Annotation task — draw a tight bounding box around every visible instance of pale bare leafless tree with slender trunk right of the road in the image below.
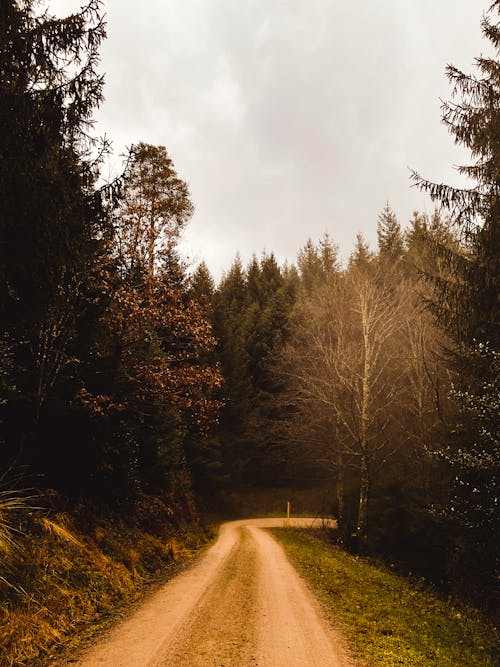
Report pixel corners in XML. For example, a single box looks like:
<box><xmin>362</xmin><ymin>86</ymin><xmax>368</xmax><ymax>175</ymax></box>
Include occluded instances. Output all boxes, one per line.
<box><xmin>282</xmin><ymin>267</ymin><xmax>406</xmax><ymax>538</ymax></box>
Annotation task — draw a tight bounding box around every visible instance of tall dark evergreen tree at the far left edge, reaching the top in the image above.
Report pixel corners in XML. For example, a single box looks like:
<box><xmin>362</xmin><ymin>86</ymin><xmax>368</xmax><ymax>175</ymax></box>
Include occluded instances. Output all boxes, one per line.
<box><xmin>0</xmin><ymin>0</ymin><xmax>106</xmax><ymax>483</ymax></box>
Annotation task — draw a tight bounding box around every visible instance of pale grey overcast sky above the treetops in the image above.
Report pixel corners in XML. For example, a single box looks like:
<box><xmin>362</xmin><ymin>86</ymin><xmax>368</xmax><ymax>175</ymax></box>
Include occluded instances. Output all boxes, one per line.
<box><xmin>50</xmin><ymin>0</ymin><xmax>487</xmax><ymax>277</ymax></box>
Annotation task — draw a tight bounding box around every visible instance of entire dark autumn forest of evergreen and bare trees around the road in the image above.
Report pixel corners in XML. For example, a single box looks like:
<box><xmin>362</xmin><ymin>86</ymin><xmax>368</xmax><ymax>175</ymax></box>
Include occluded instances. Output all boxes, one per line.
<box><xmin>0</xmin><ymin>0</ymin><xmax>500</xmax><ymax>652</ymax></box>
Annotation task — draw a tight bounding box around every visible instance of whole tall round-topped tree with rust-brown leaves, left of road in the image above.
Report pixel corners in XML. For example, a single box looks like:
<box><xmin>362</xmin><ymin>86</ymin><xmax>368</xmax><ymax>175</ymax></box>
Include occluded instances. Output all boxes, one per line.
<box><xmin>89</xmin><ymin>143</ymin><xmax>221</xmax><ymax>492</ymax></box>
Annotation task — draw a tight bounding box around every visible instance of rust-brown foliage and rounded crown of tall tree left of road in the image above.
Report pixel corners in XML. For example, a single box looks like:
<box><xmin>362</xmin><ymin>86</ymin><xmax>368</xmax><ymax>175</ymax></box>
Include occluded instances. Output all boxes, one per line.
<box><xmin>87</xmin><ymin>144</ymin><xmax>222</xmax><ymax>432</ymax></box>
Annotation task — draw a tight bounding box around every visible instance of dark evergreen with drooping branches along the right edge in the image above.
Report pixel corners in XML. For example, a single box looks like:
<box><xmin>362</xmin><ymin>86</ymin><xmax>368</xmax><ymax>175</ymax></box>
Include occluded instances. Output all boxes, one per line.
<box><xmin>413</xmin><ymin>0</ymin><xmax>500</xmax><ymax>601</ymax></box>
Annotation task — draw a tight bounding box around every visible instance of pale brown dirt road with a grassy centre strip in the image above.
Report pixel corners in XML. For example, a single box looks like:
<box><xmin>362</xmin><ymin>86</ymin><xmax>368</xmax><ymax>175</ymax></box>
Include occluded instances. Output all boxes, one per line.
<box><xmin>77</xmin><ymin>519</ymin><xmax>352</xmax><ymax>667</ymax></box>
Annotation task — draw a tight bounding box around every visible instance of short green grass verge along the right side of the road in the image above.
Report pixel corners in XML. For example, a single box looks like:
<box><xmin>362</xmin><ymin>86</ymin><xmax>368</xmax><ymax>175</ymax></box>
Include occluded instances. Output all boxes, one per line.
<box><xmin>271</xmin><ymin>528</ymin><xmax>500</xmax><ymax>667</ymax></box>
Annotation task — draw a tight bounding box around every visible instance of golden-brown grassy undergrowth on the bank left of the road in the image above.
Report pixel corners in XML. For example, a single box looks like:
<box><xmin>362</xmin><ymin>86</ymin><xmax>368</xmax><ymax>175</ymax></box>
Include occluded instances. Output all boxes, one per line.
<box><xmin>0</xmin><ymin>497</ymin><xmax>208</xmax><ymax>667</ymax></box>
